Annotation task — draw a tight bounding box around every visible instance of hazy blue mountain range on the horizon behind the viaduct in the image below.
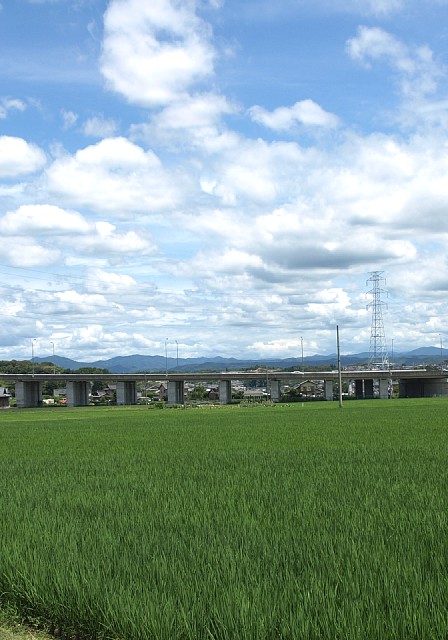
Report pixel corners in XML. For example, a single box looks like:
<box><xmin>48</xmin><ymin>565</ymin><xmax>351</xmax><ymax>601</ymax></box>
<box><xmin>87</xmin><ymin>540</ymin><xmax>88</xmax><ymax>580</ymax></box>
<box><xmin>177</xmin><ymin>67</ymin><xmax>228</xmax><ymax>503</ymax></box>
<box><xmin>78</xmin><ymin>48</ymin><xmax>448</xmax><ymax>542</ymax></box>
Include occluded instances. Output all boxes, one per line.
<box><xmin>33</xmin><ymin>347</ymin><xmax>448</xmax><ymax>373</ymax></box>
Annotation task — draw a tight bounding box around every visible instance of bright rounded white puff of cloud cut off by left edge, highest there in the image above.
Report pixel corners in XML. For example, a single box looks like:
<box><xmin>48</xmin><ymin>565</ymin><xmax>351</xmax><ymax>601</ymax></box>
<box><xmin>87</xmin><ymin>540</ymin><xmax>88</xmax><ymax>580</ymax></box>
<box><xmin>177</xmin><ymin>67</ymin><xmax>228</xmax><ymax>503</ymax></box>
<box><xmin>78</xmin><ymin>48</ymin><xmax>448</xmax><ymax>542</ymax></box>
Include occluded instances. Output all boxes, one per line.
<box><xmin>0</xmin><ymin>136</ymin><xmax>47</xmax><ymax>178</ymax></box>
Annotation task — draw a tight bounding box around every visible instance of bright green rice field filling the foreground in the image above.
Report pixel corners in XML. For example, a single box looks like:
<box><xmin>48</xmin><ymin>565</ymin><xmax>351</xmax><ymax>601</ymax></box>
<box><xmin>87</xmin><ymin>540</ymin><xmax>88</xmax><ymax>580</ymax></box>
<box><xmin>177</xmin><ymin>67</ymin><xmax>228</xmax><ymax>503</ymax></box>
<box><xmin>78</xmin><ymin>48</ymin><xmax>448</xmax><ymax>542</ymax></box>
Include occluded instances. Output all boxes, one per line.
<box><xmin>0</xmin><ymin>398</ymin><xmax>448</xmax><ymax>640</ymax></box>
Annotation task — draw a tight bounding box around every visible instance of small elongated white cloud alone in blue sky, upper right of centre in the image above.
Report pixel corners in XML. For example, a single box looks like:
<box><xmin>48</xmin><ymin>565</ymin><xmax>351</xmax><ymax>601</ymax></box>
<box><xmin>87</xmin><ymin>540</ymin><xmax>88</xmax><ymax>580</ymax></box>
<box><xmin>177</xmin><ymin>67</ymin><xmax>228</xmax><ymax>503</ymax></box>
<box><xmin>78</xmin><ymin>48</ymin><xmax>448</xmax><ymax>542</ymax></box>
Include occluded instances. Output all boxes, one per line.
<box><xmin>249</xmin><ymin>100</ymin><xmax>339</xmax><ymax>131</ymax></box>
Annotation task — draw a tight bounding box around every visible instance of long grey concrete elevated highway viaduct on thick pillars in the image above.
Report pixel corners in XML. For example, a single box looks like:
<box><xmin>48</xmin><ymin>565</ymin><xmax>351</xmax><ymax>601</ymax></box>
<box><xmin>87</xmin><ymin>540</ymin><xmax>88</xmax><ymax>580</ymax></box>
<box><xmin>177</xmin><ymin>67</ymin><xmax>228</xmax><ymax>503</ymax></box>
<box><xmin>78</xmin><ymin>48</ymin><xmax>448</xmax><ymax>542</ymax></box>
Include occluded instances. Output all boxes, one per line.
<box><xmin>0</xmin><ymin>369</ymin><xmax>448</xmax><ymax>408</ymax></box>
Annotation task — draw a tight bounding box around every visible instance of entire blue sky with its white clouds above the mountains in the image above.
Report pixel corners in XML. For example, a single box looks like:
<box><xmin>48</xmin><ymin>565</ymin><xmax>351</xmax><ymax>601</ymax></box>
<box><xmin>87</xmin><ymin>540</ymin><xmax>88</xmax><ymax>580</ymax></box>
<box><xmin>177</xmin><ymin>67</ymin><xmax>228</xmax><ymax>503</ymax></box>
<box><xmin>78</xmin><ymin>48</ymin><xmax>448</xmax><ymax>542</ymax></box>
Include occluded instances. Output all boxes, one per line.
<box><xmin>0</xmin><ymin>0</ymin><xmax>448</xmax><ymax>361</ymax></box>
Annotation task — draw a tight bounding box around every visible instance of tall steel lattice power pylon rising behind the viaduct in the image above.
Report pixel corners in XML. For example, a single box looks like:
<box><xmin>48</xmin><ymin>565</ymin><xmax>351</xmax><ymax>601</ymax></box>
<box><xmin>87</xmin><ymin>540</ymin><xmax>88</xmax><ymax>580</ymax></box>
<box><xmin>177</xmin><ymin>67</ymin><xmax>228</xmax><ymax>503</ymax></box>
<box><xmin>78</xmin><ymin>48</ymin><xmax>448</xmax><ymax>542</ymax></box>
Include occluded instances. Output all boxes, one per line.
<box><xmin>367</xmin><ymin>271</ymin><xmax>389</xmax><ymax>369</ymax></box>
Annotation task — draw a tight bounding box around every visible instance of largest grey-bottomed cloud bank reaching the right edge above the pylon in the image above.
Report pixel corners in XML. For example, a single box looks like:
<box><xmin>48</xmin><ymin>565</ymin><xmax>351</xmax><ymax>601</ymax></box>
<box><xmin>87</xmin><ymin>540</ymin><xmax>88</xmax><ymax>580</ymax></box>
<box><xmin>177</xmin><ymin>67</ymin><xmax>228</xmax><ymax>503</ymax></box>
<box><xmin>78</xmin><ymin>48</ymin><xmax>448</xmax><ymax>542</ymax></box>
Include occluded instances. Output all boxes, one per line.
<box><xmin>172</xmin><ymin>126</ymin><xmax>448</xmax><ymax>290</ymax></box>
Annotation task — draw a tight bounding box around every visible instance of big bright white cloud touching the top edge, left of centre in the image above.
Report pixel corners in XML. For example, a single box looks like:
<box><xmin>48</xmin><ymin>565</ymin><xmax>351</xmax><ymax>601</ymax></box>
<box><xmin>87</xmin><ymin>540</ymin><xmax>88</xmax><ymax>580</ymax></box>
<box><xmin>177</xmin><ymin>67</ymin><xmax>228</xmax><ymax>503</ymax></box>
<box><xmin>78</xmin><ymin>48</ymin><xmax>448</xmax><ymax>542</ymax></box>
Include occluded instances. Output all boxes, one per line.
<box><xmin>101</xmin><ymin>0</ymin><xmax>215</xmax><ymax>107</ymax></box>
